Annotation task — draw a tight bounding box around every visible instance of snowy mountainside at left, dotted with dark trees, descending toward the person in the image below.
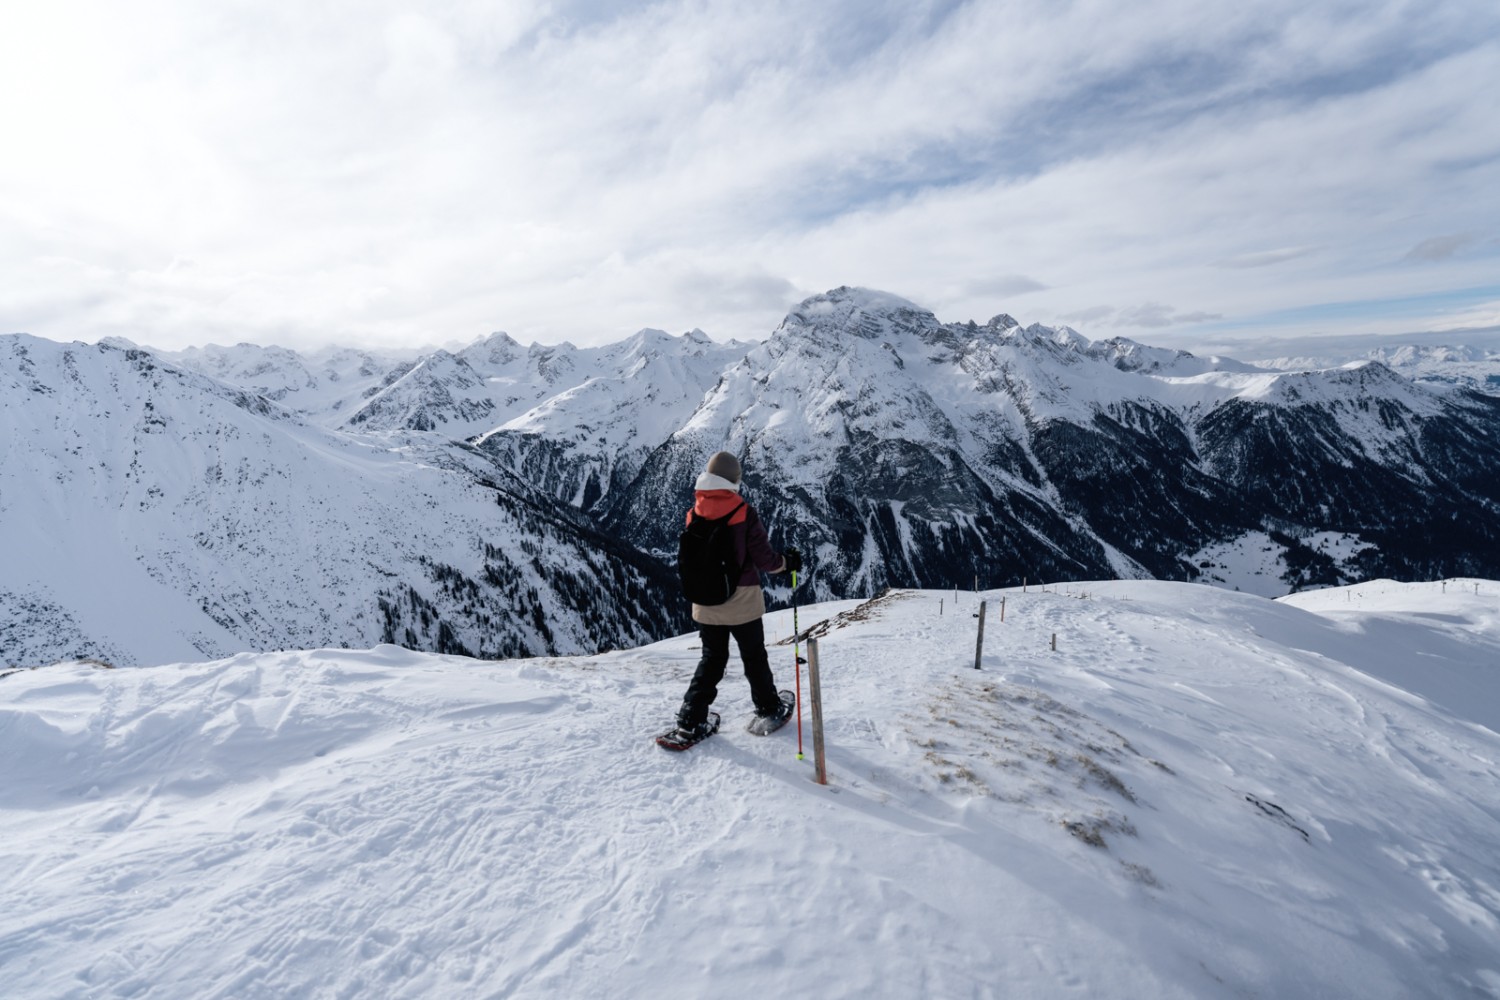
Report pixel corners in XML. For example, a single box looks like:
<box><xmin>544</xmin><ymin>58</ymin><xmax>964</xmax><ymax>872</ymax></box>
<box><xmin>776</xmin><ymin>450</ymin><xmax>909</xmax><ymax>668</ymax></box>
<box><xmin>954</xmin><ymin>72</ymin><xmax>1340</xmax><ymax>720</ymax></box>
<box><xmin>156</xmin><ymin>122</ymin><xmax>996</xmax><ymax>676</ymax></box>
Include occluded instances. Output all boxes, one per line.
<box><xmin>0</xmin><ymin>334</ymin><xmax>669</xmax><ymax>666</ymax></box>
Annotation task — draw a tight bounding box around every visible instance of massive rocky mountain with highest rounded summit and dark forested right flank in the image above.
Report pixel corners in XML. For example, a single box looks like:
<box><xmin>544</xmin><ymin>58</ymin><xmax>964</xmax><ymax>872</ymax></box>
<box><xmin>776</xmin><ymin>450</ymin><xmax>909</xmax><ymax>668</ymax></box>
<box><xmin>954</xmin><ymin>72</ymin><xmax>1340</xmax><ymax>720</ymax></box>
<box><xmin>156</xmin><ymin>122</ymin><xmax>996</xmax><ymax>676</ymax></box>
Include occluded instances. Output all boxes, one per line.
<box><xmin>599</xmin><ymin>289</ymin><xmax>1500</xmax><ymax>597</ymax></box>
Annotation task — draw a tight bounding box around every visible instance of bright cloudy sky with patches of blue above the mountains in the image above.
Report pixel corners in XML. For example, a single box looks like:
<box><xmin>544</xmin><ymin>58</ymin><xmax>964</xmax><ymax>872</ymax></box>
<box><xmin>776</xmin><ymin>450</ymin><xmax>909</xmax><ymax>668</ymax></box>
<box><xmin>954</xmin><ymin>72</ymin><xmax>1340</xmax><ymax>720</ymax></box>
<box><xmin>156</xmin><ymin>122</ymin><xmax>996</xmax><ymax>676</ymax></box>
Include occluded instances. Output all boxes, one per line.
<box><xmin>0</xmin><ymin>0</ymin><xmax>1500</xmax><ymax>348</ymax></box>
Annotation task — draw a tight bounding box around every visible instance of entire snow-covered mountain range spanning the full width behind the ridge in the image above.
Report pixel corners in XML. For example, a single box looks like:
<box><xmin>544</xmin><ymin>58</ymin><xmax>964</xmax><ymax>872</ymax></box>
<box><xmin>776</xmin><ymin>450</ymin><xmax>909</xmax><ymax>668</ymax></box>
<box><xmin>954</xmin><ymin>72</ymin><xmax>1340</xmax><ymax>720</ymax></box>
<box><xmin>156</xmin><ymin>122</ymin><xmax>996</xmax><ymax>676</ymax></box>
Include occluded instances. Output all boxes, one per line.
<box><xmin>0</xmin><ymin>288</ymin><xmax>1500</xmax><ymax>663</ymax></box>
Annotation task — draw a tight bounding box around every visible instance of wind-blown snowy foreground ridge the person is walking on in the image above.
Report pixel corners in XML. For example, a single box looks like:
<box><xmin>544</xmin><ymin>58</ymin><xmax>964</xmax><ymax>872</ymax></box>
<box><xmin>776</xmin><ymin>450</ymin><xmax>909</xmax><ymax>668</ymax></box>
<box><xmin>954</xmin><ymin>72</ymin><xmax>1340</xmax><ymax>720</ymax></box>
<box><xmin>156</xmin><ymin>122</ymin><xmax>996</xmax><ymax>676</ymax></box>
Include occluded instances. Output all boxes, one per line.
<box><xmin>0</xmin><ymin>580</ymin><xmax>1500</xmax><ymax>999</ymax></box>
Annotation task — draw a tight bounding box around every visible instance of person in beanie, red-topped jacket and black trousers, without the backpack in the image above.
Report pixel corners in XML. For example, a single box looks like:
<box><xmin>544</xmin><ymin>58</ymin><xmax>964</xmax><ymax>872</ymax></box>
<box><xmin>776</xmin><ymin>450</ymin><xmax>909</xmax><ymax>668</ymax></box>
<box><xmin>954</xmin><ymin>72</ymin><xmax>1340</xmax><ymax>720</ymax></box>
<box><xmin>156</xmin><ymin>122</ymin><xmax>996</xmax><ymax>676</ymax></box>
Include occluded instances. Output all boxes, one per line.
<box><xmin>677</xmin><ymin>451</ymin><xmax>803</xmax><ymax>735</ymax></box>
